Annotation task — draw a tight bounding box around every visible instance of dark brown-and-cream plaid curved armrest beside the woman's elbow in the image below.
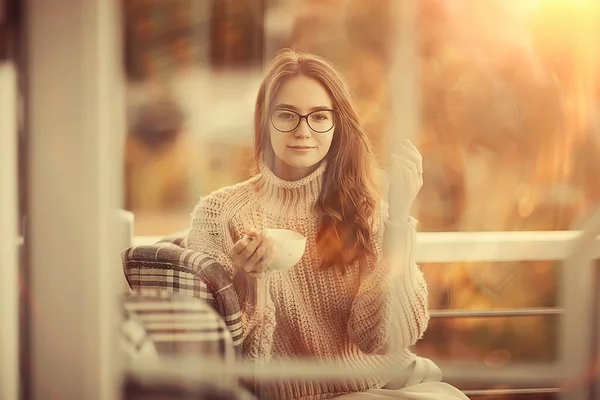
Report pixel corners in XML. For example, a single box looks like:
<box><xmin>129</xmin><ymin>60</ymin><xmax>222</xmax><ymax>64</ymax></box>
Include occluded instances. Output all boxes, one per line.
<box><xmin>122</xmin><ymin>237</ymin><xmax>242</xmax><ymax>351</ymax></box>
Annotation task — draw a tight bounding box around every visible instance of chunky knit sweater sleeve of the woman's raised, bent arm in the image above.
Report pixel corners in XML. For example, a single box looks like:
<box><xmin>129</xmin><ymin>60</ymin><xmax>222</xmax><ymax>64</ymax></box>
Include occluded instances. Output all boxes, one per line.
<box><xmin>348</xmin><ymin>205</ymin><xmax>429</xmax><ymax>354</ymax></box>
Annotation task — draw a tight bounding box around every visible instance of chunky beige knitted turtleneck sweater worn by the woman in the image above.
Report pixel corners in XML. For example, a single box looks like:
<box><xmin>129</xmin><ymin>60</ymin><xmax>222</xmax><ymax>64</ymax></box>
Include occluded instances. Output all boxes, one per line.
<box><xmin>186</xmin><ymin>164</ymin><xmax>429</xmax><ymax>399</ymax></box>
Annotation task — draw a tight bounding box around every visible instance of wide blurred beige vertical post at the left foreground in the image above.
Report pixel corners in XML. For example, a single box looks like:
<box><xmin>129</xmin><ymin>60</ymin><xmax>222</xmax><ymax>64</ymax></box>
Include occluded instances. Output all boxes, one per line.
<box><xmin>25</xmin><ymin>0</ymin><xmax>124</xmax><ymax>399</ymax></box>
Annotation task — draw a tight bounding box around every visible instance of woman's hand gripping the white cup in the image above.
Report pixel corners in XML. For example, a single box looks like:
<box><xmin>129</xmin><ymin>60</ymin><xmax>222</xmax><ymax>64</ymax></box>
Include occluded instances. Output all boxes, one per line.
<box><xmin>229</xmin><ymin>229</ymin><xmax>275</xmax><ymax>276</ymax></box>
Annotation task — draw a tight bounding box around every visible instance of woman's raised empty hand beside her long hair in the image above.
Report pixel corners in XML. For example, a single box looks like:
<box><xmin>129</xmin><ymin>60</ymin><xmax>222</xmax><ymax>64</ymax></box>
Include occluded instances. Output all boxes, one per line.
<box><xmin>388</xmin><ymin>139</ymin><xmax>423</xmax><ymax>223</ymax></box>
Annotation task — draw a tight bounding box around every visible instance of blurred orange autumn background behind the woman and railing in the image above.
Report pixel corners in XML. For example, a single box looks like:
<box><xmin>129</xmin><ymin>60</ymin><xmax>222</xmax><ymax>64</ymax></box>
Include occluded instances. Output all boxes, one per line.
<box><xmin>3</xmin><ymin>0</ymin><xmax>600</xmax><ymax>399</ymax></box>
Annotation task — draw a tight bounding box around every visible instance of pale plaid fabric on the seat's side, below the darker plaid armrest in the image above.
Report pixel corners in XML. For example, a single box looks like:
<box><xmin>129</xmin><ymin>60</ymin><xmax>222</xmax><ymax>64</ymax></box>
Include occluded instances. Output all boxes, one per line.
<box><xmin>121</xmin><ymin>289</ymin><xmax>255</xmax><ymax>400</ymax></box>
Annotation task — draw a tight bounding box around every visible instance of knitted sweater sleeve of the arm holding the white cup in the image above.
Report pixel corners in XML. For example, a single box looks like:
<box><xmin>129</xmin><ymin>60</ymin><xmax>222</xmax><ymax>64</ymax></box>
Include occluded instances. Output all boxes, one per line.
<box><xmin>186</xmin><ymin>190</ymin><xmax>275</xmax><ymax>360</ymax></box>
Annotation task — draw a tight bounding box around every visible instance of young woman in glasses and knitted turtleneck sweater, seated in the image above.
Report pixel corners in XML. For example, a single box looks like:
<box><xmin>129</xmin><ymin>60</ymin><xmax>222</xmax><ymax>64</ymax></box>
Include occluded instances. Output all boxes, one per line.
<box><xmin>187</xmin><ymin>50</ymin><xmax>466</xmax><ymax>399</ymax></box>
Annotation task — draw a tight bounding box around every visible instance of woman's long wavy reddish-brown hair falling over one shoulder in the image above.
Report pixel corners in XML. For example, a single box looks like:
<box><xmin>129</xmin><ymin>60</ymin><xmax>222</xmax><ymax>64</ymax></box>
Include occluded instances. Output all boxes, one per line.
<box><xmin>254</xmin><ymin>49</ymin><xmax>379</xmax><ymax>270</ymax></box>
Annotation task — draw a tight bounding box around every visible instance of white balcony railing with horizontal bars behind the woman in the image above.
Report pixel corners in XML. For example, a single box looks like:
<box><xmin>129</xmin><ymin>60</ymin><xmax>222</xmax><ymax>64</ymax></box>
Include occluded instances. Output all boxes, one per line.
<box><xmin>133</xmin><ymin>231</ymin><xmax>600</xmax><ymax>399</ymax></box>
